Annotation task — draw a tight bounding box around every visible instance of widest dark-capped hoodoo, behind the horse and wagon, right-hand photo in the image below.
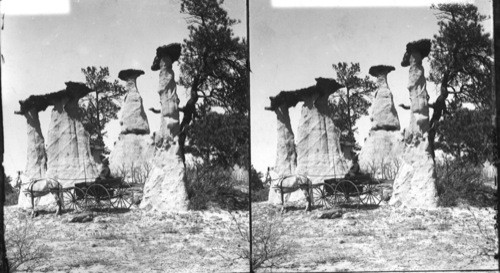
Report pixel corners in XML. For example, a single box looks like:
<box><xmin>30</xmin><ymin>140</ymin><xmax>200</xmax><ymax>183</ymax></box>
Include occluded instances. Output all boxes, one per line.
<box><xmin>296</xmin><ymin>78</ymin><xmax>347</xmax><ymax>184</ymax></box>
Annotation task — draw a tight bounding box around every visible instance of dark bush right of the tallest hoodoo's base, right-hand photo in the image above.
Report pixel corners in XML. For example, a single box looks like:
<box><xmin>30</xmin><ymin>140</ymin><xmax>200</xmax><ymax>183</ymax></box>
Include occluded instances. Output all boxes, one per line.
<box><xmin>436</xmin><ymin>159</ymin><xmax>496</xmax><ymax>207</ymax></box>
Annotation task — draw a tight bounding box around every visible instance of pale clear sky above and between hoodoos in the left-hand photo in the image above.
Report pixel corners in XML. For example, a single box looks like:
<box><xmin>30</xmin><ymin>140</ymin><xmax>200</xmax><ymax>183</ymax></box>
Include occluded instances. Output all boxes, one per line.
<box><xmin>1</xmin><ymin>0</ymin><xmax>247</xmax><ymax>178</ymax></box>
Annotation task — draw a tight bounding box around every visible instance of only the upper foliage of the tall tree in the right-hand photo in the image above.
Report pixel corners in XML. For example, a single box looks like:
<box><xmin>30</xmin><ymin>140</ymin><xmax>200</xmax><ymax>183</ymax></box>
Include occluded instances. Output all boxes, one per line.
<box><xmin>429</xmin><ymin>4</ymin><xmax>493</xmax><ymax>109</ymax></box>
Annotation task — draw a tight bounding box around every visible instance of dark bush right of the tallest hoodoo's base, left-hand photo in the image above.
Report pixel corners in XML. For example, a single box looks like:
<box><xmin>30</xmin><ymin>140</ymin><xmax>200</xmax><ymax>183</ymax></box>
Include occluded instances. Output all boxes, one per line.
<box><xmin>186</xmin><ymin>163</ymin><xmax>249</xmax><ymax>210</ymax></box>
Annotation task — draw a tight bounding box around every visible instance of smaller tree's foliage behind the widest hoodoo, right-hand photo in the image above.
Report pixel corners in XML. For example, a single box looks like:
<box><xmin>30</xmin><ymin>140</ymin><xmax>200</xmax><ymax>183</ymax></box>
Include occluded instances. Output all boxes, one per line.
<box><xmin>330</xmin><ymin>62</ymin><xmax>376</xmax><ymax>146</ymax></box>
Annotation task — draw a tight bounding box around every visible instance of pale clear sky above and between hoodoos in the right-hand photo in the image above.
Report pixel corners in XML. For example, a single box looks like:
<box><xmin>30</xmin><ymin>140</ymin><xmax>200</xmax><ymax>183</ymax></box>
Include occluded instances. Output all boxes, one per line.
<box><xmin>249</xmin><ymin>0</ymin><xmax>492</xmax><ymax>173</ymax></box>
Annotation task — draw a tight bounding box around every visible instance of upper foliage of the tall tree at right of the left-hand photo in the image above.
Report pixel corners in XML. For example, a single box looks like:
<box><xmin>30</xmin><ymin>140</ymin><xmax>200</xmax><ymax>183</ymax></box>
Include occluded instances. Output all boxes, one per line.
<box><xmin>180</xmin><ymin>0</ymin><xmax>249</xmax><ymax>113</ymax></box>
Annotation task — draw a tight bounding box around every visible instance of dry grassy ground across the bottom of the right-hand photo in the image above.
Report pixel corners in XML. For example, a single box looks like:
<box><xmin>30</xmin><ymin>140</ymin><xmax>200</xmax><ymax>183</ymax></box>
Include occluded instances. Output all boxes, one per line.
<box><xmin>252</xmin><ymin>199</ymin><xmax>498</xmax><ymax>272</ymax></box>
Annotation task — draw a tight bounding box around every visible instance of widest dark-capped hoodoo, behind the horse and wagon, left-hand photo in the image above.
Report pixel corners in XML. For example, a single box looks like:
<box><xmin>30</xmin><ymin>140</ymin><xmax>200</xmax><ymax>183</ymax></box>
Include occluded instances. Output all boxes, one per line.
<box><xmin>44</xmin><ymin>82</ymin><xmax>97</xmax><ymax>187</ymax></box>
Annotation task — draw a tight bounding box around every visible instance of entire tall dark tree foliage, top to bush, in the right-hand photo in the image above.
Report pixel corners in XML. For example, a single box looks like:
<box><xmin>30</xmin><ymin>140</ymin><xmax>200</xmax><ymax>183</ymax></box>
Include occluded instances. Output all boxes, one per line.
<box><xmin>429</xmin><ymin>4</ymin><xmax>495</xmax><ymax>163</ymax></box>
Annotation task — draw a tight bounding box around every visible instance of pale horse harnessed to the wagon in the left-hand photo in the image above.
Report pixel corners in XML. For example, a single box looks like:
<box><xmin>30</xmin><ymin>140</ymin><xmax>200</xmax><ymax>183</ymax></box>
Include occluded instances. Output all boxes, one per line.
<box><xmin>24</xmin><ymin>178</ymin><xmax>64</xmax><ymax>218</ymax></box>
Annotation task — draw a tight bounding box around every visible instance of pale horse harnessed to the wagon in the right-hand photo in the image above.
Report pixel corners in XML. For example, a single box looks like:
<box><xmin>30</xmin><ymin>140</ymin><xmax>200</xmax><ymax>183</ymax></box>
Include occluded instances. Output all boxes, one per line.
<box><xmin>272</xmin><ymin>174</ymin><xmax>313</xmax><ymax>213</ymax></box>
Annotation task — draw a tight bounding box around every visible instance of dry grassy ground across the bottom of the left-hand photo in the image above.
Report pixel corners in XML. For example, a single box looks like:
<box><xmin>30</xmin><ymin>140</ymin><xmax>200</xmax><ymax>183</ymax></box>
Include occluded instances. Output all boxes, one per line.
<box><xmin>5</xmin><ymin>207</ymin><xmax>249</xmax><ymax>272</ymax></box>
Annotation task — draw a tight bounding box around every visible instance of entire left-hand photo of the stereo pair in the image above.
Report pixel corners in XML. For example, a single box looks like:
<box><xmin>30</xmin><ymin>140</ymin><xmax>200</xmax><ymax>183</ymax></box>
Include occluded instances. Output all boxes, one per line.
<box><xmin>0</xmin><ymin>0</ymin><xmax>252</xmax><ymax>272</ymax></box>
